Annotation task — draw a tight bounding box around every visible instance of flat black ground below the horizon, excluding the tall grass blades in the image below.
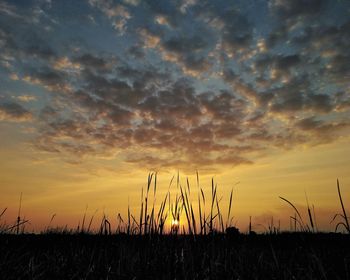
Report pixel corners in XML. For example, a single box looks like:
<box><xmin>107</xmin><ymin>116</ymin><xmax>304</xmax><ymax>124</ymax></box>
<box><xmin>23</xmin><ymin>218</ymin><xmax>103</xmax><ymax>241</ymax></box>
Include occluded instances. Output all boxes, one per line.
<box><xmin>0</xmin><ymin>234</ymin><xmax>350</xmax><ymax>280</ymax></box>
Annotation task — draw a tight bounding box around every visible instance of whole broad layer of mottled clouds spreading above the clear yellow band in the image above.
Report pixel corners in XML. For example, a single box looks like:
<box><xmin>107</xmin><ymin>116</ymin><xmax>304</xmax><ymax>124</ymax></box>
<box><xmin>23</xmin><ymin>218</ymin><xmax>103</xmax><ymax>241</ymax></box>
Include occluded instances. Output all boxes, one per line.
<box><xmin>0</xmin><ymin>0</ymin><xmax>350</xmax><ymax>171</ymax></box>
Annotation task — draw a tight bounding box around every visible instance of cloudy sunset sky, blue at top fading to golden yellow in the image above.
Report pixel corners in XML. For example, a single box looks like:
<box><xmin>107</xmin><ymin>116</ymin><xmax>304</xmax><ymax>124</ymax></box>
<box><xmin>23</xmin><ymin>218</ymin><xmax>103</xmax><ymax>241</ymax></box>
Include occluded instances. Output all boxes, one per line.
<box><xmin>0</xmin><ymin>0</ymin><xmax>350</xmax><ymax>230</ymax></box>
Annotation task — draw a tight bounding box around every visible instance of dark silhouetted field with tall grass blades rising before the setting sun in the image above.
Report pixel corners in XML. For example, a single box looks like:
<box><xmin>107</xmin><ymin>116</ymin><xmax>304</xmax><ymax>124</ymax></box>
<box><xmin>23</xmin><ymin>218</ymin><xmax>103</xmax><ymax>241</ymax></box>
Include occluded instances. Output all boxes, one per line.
<box><xmin>0</xmin><ymin>174</ymin><xmax>350</xmax><ymax>279</ymax></box>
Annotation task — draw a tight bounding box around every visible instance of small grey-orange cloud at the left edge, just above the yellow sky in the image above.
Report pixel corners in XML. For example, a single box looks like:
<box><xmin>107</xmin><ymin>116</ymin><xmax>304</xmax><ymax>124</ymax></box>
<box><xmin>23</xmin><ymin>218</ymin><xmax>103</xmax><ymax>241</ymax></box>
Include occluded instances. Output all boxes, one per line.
<box><xmin>0</xmin><ymin>102</ymin><xmax>33</xmax><ymax>122</ymax></box>
